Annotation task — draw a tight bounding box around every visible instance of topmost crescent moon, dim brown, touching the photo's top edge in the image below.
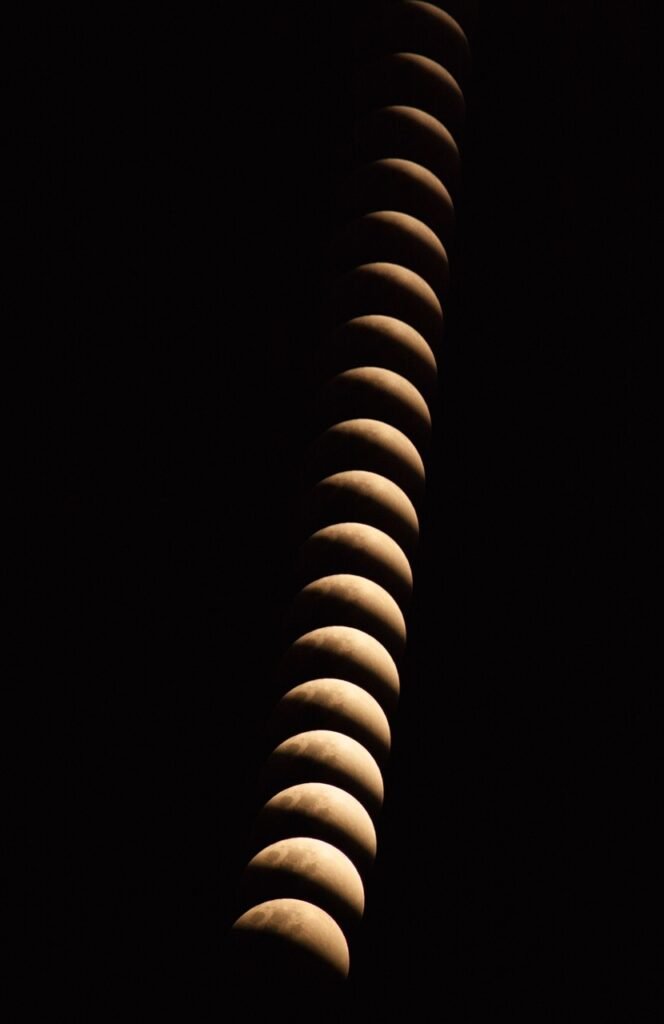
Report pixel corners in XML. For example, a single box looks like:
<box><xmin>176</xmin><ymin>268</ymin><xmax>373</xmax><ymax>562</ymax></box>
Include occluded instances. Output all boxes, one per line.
<box><xmin>365</xmin><ymin>0</ymin><xmax>470</xmax><ymax>83</ymax></box>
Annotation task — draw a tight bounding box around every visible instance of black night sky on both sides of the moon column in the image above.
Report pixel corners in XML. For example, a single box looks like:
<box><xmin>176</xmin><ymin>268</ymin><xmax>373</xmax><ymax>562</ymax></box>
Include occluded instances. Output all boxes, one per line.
<box><xmin>29</xmin><ymin>0</ymin><xmax>647</xmax><ymax>1022</ymax></box>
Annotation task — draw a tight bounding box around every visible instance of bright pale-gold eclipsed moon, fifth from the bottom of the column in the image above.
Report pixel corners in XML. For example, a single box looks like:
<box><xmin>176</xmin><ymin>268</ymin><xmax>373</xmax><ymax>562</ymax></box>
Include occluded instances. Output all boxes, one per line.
<box><xmin>268</xmin><ymin>679</ymin><xmax>391</xmax><ymax>764</ymax></box>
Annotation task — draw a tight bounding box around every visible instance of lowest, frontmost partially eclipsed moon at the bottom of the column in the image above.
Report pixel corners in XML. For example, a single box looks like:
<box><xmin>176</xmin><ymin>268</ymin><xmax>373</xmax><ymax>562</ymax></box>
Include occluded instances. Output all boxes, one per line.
<box><xmin>232</xmin><ymin>898</ymin><xmax>349</xmax><ymax>994</ymax></box>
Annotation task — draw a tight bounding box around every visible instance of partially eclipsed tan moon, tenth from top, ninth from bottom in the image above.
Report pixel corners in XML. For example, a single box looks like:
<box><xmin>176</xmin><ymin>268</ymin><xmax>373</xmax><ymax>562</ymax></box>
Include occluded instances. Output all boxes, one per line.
<box><xmin>304</xmin><ymin>469</ymin><xmax>419</xmax><ymax>556</ymax></box>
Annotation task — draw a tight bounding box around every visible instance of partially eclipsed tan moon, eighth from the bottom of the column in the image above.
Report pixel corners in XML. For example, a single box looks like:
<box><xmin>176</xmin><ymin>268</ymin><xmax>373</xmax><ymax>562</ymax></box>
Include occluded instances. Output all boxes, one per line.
<box><xmin>297</xmin><ymin>522</ymin><xmax>413</xmax><ymax>612</ymax></box>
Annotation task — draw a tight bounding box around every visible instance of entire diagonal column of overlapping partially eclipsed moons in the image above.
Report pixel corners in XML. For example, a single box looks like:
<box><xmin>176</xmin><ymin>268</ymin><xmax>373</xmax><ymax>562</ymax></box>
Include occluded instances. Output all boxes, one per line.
<box><xmin>232</xmin><ymin>0</ymin><xmax>476</xmax><ymax>986</ymax></box>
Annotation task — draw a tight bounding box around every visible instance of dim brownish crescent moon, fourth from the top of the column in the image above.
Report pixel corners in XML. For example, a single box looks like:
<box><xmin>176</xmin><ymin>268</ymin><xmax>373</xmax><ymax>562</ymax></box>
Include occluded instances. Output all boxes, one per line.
<box><xmin>339</xmin><ymin>157</ymin><xmax>454</xmax><ymax>245</ymax></box>
